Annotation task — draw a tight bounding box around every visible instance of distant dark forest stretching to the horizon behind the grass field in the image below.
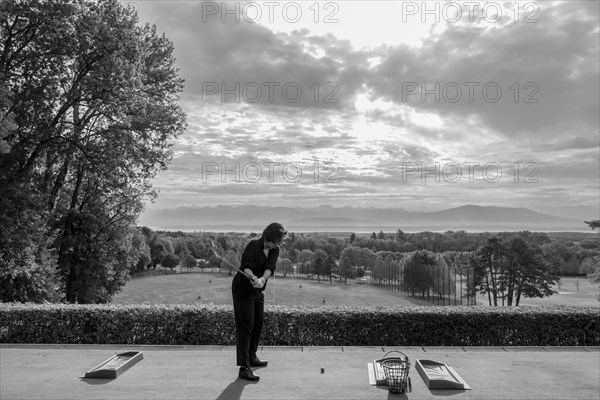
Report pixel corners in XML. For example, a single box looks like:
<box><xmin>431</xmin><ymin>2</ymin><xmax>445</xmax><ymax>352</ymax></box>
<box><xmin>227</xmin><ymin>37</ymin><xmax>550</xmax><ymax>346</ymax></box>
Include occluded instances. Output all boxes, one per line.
<box><xmin>143</xmin><ymin>227</ymin><xmax>600</xmax><ymax>276</ymax></box>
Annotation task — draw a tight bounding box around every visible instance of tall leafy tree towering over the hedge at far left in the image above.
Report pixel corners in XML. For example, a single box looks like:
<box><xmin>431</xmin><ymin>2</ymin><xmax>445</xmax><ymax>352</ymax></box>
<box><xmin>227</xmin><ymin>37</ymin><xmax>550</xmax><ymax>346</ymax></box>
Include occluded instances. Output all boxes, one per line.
<box><xmin>0</xmin><ymin>0</ymin><xmax>185</xmax><ymax>303</ymax></box>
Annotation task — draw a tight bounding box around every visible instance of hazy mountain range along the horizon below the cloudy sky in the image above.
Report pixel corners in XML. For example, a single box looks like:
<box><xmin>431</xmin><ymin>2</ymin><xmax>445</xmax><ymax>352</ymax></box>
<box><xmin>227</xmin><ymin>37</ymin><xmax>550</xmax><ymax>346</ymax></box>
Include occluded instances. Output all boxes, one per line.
<box><xmin>139</xmin><ymin>205</ymin><xmax>593</xmax><ymax>232</ymax></box>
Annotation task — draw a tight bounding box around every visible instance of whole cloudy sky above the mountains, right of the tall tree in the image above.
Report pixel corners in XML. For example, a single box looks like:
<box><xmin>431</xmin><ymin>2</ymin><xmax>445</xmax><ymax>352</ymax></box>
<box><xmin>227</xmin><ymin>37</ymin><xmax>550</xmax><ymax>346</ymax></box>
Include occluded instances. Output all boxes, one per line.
<box><xmin>132</xmin><ymin>0</ymin><xmax>600</xmax><ymax>218</ymax></box>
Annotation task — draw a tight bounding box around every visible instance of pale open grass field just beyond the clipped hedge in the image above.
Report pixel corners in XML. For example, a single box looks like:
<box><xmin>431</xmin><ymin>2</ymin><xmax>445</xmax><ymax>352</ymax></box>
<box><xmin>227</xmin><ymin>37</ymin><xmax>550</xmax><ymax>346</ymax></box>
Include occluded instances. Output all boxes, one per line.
<box><xmin>113</xmin><ymin>272</ymin><xmax>600</xmax><ymax>307</ymax></box>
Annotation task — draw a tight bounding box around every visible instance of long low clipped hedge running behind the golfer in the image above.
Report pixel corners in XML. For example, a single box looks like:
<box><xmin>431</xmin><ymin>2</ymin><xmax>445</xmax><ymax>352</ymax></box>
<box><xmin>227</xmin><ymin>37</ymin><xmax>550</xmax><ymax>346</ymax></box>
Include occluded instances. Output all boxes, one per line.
<box><xmin>0</xmin><ymin>304</ymin><xmax>600</xmax><ymax>346</ymax></box>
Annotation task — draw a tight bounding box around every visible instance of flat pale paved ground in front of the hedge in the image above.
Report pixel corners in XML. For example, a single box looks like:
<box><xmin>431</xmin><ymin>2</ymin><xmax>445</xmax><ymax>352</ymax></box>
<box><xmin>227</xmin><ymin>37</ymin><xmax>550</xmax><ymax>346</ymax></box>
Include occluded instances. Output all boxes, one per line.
<box><xmin>0</xmin><ymin>344</ymin><xmax>600</xmax><ymax>400</ymax></box>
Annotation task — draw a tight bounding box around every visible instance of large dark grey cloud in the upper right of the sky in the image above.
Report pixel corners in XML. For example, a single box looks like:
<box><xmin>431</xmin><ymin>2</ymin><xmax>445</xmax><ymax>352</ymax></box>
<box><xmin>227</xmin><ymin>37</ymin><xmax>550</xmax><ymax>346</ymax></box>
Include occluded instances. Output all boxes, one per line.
<box><xmin>369</xmin><ymin>2</ymin><xmax>600</xmax><ymax>139</ymax></box>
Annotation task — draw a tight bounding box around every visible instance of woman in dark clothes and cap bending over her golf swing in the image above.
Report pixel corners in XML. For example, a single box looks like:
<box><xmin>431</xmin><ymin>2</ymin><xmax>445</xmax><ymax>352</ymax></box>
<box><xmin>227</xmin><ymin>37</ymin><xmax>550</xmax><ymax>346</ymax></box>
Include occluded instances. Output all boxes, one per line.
<box><xmin>231</xmin><ymin>222</ymin><xmax>287</xmax><ymax>381</ymax></box>
